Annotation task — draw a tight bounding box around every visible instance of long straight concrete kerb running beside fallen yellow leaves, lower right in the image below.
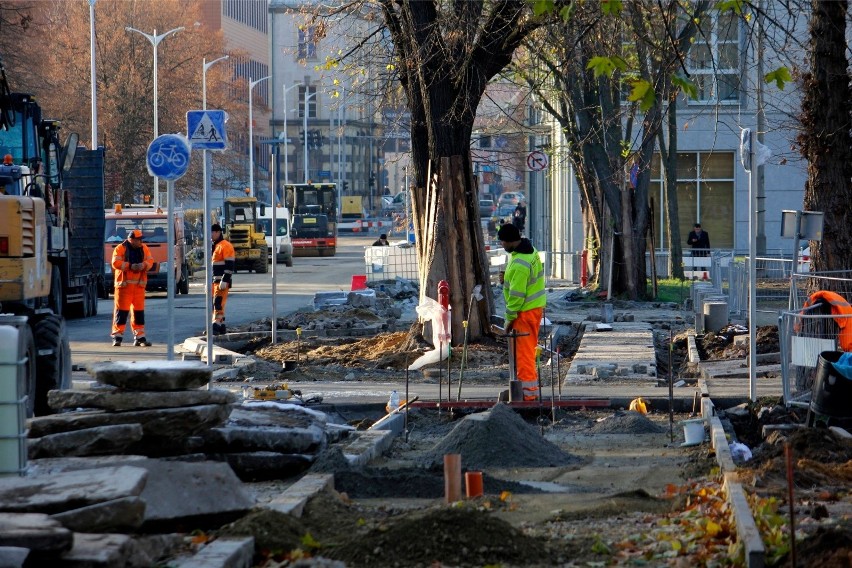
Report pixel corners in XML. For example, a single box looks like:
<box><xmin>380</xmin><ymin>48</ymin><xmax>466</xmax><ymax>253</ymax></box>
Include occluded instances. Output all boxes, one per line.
<box><xmin>701</xmin><ymin>397</ymin><xmax>766</xmax><ymax>568</ymax></box>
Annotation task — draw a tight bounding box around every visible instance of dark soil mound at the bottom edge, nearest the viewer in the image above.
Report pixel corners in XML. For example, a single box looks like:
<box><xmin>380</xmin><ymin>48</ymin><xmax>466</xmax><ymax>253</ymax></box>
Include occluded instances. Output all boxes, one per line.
<box><xmin>325</xmin><ymin>507</ymin><xmax>550</xmax><ymax>567</ymax></box>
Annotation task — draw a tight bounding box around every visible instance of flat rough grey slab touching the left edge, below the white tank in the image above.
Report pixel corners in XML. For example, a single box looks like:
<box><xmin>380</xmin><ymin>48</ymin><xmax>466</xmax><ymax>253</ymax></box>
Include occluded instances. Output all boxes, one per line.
<box><xmin>0</xmin><ymin>462</ymin><xmax>148</xmax><ymax>513</ymax></box>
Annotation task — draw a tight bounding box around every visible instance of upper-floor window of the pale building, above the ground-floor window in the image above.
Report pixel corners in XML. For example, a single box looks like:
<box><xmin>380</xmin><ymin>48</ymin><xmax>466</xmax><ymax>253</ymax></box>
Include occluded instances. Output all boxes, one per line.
<box><xmin>687</xmin><ymin>10</ymin><xmax>740</xmax><ymax>104</ymax></box>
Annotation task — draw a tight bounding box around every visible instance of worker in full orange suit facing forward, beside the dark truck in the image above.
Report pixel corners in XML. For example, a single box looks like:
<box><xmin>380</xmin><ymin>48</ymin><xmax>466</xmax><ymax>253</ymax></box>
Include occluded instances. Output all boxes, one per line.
<box><xmin>111</xmin><ymin>229</ymin><xmax>154</xmax><ymax>347</ymax></box>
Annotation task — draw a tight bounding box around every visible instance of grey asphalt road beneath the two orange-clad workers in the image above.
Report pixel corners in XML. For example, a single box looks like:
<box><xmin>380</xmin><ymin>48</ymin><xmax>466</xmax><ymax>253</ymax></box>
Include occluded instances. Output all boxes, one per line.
<box><xmin>66</xmin><ymin>235</ymin><xmax>376</xmax><ymax>366</ymax></box>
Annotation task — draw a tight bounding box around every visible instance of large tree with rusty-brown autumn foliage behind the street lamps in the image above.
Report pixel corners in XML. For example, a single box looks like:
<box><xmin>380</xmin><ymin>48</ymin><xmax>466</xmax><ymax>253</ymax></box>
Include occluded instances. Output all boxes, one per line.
<box><xmin>0</xmin><ymin>0</ymin><xmax>247</xmax><ymax>203</ymax></box>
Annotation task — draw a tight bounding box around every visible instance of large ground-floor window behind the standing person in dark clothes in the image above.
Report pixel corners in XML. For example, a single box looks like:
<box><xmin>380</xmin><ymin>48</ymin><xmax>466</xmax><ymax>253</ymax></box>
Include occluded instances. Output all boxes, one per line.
<box><xmin>651</xmin><ymin>152</ymin><xmax>735</xmax><ymax>248</ymax></box>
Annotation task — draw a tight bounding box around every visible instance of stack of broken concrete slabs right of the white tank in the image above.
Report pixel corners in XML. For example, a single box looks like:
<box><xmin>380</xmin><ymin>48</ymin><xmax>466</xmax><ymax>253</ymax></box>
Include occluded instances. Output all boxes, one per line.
<box><xmin>28</xmin><ymin>361</ymin><xmax>237</xmax><ymax>459</ymax></box>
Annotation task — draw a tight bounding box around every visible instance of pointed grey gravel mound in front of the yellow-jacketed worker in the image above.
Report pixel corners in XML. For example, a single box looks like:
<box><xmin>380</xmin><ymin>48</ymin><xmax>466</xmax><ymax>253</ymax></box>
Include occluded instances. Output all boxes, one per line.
<box><xmin>427</xmin><ymin>404</ymin><xmax>580</xmax><ymax>470</ymax></box>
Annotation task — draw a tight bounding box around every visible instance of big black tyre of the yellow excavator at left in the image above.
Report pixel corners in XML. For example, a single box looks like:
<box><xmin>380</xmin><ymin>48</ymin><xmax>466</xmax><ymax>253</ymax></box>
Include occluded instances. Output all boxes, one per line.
<box><xmin>33</xmin><ymin>315</ymin><xmax>71</xmax><ymax>416</ymax></box>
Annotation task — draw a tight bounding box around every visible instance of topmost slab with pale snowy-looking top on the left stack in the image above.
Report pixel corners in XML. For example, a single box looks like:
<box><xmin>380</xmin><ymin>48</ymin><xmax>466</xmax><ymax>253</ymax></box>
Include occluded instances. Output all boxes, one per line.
<box><xmin>88</xmin><ymin>361</ymin><xmax>213</xmax><ymax>391</ymax></box>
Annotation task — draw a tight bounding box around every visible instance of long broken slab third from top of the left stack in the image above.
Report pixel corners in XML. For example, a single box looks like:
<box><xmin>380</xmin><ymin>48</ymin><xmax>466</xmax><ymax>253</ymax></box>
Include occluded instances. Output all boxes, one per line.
<box><xmin>28</xmin><ymin>404</ymin><xmax>231</xmax><ymax>439</ymax></box>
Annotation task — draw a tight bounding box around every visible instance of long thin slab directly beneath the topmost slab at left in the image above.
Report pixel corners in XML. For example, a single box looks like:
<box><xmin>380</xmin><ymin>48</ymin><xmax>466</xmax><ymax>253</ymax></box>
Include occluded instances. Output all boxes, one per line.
<box><xmin>47</xmin><ymin>389</ymin><xmax>238</xmax><ymax>412</ymax></box>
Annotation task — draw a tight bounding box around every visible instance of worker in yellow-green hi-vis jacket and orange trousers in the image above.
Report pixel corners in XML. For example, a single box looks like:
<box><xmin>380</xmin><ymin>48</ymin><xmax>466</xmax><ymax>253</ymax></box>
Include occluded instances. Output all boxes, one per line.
<box><xmin>497</xmin><ymin>223</ymin><xmax>547</xmax><ymax>400</ymax></box>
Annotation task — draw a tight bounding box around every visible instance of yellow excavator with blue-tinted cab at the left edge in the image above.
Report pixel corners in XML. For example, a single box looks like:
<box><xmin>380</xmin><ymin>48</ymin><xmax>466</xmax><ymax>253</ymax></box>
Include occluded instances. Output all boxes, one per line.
<box><xmin>0</xmin><ymin>58</ymin><xmax>93</xmax><ymax>416</ymax></box>
